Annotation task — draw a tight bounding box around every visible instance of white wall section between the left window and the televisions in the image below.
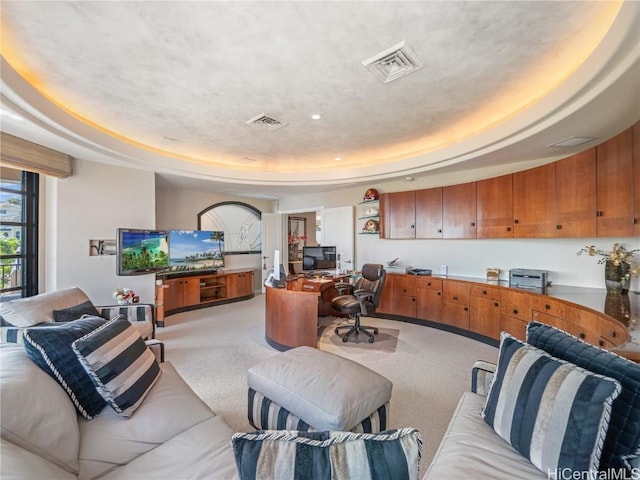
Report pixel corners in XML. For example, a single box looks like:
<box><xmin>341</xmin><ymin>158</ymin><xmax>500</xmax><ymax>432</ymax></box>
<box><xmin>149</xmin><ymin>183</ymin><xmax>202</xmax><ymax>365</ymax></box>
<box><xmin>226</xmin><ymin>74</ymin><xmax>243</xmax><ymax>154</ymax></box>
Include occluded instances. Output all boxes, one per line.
<box><xmin>43</xmin><ymin>160</ymin><xmax>156</xmax><ymax>305</ymax></box>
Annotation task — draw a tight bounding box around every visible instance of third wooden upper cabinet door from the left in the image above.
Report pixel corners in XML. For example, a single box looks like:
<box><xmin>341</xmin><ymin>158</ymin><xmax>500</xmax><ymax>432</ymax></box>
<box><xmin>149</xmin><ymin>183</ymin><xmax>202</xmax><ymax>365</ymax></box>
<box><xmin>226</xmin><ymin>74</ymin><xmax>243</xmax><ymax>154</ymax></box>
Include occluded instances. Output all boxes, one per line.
<box><xmin>442</xmin><ymin>182</ymin><xmax>476</xmax><ymax>238</ymax></box>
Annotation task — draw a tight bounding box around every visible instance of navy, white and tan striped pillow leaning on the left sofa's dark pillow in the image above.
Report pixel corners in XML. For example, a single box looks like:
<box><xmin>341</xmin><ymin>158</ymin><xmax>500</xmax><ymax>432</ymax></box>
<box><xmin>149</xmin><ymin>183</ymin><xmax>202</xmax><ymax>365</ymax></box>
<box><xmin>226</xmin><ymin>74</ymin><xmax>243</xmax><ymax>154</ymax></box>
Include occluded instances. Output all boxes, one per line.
<box><xmin>72</xmin><ymin>317</ymin><xmax>161</xmax><ymax>417</ymax></box>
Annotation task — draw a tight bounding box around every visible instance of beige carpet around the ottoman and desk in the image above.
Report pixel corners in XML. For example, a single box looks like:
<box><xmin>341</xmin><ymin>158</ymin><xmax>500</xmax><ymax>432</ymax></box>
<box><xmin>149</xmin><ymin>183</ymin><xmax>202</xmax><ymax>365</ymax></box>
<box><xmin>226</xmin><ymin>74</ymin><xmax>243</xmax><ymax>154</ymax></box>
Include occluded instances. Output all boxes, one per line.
<box><xmin>157</xmin><ymin>295</ymin><xmax>498</xmax><ymax>472</ymax></box>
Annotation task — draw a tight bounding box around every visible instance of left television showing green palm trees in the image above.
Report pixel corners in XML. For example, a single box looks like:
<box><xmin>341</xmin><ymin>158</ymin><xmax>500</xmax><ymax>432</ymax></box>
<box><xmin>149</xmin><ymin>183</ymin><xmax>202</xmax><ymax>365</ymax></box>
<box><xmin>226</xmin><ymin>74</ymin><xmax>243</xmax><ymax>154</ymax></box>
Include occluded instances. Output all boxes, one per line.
<box><xmin>116</xmin><ymin>228</ymin><xmax>169</xmax><ymax>276</ymax></box>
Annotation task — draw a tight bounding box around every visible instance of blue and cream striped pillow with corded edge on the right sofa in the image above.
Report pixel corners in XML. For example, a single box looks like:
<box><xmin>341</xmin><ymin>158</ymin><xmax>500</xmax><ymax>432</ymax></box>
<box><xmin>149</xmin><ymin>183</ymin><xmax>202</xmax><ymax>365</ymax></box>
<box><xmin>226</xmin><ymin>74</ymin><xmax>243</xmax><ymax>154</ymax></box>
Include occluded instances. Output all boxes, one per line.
<box><xmin>482</xmin><ymin>332</ymin><xmax>621</xmax><ymax>478</ymax></box>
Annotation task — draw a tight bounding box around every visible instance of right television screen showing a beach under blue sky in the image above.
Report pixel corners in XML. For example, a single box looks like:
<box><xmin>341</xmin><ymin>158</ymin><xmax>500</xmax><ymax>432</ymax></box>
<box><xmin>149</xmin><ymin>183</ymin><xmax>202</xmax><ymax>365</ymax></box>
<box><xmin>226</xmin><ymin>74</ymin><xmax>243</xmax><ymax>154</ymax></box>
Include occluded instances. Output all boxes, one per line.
<box><xmin>169</xmin><ymin>230</ymin><xmax>224</xmax><ymax>271</ymax></box>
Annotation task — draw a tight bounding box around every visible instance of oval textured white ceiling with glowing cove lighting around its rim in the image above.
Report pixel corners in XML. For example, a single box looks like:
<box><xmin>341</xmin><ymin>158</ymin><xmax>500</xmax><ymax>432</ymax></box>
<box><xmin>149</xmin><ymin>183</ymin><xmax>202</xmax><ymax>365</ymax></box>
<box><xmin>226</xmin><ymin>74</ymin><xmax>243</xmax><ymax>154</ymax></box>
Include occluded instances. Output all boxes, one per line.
<box><xmin>0</xmin><ymin>0</ymin><xmax>640</xmax><ymax>197</ymax></box>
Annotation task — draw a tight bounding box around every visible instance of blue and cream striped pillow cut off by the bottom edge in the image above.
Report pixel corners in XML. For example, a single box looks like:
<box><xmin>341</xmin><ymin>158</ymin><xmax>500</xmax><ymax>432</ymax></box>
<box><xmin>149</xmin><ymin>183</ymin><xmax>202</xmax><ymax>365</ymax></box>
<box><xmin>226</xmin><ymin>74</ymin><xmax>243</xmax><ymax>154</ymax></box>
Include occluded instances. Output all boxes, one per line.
<box><xmin>231</xmin><ymin>428</ymin><xmax>422</xmax><ymax>480</ymax></box>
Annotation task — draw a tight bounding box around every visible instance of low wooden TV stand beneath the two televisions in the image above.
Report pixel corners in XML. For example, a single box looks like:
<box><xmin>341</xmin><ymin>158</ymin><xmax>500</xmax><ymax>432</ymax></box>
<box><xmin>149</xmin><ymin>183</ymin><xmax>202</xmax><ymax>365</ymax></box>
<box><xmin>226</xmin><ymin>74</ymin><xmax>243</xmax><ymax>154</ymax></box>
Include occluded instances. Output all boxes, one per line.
<box><xmin>156</xmin><ymin>270</ymin><xmax>255</xmax><ymax>327</ymax></box>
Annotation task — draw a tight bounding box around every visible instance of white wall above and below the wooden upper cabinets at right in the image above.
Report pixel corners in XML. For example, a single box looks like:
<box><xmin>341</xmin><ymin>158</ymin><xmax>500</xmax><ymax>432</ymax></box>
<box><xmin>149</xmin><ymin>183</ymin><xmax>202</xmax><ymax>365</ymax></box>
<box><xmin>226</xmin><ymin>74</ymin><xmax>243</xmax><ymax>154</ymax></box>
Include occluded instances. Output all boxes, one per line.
<box><xmin>278</xmin><ymin>182</ymin><xmax>640</xmax><ymax>291</ymax></box>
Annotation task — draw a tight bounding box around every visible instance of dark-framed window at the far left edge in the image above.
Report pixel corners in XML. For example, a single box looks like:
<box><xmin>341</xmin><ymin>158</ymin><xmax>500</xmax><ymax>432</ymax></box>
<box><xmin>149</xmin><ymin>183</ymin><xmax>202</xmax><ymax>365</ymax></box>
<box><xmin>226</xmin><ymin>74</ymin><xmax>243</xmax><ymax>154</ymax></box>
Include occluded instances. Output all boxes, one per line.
<box><xmin>0</xmin><ymin>169</ymin><xmax>39</xmax><ymax>302</ymax></box>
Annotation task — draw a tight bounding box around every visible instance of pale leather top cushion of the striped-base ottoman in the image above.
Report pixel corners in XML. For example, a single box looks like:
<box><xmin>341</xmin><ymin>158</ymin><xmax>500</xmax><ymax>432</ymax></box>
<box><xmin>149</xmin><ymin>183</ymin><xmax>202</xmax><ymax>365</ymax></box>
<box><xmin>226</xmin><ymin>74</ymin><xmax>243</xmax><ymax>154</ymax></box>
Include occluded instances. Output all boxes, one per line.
<box><xmin>248</xmin><ymin>347</ymin><xmax>393</xmax><ymax>430</ymax></box>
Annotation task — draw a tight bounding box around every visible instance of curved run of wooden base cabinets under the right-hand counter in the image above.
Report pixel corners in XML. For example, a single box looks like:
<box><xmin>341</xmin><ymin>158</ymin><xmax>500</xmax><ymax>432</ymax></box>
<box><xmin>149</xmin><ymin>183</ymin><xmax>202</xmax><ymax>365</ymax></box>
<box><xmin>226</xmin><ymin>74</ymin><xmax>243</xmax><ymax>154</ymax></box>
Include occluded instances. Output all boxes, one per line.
<box><xmin>377</xmin><ymin>274</ymin><xmax>631</xmax><ymax>348</ymax></box>
